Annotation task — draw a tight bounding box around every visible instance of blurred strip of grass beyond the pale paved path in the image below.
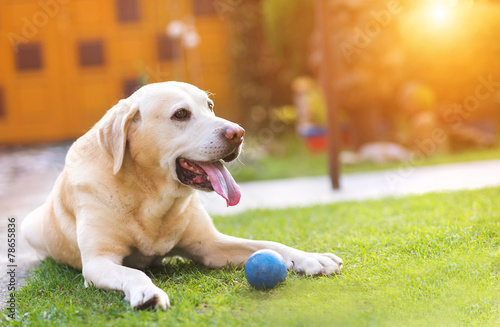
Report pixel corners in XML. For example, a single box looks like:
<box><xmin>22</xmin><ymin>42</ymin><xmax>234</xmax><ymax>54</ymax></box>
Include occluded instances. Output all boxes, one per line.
<box><xmin>229</xmin><ymin>134</ymin><xmax>500</xmax><ymax>182</ymax></box>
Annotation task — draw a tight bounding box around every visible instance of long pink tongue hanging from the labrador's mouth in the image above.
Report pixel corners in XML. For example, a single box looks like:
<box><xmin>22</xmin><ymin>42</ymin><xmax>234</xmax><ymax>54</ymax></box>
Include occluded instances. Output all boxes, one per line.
<box><xmin>198</xmin><ymin>161</ymin><xmax>241</xmax><ymax>206</ymax></box>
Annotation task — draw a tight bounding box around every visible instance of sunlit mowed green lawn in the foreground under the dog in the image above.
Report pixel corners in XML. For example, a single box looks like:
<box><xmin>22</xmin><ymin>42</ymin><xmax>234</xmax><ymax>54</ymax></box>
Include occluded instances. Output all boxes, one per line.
<box><xmin>1</xmin><ymin>188</ymin><xmax>500</xmax><ymax>326</ymax></box>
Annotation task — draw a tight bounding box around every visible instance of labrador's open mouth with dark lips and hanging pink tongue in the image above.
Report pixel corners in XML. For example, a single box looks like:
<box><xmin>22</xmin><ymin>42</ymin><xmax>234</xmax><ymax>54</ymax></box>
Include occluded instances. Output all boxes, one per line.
<box><xmin>176</xmin><ymin>158</ymin><xmax>241</xmax><ymax>206</ymax></box>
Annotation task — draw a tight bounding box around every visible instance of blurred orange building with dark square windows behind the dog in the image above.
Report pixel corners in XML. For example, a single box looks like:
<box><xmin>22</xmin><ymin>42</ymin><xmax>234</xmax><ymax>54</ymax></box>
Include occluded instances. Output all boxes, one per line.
<box><xmin>0</xmin><ymin>0</ymin><xmax>240</xmax><ymax>144</ymax></box>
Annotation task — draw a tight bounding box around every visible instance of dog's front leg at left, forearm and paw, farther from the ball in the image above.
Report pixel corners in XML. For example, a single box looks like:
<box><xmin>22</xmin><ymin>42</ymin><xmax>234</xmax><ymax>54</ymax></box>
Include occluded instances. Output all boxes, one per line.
<box><xmin>82</xmin><ymin>256</ymin><xmax>170</xmax><ymax>310</ymax></box>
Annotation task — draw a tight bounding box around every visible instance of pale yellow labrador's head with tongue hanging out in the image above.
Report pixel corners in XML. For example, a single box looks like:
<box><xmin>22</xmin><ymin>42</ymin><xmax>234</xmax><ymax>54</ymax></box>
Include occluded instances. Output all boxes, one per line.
<box><xmin>96</xmin><ymin>82</ymin><xmax>245</xmax><ymax>205</ymax></box>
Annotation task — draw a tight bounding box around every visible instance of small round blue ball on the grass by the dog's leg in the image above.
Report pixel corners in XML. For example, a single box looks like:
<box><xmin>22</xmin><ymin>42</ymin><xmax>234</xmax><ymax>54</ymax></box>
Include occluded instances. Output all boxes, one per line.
<box><xmin>245</xmin><ymin>250</ymin><xmax>287</xmax><ymax>290</ymax></box>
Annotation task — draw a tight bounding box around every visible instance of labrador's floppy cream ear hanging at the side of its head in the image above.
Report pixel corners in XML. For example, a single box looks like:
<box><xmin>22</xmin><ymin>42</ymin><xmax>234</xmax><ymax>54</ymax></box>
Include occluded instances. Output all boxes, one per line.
<box><xmin>97</xmin><ymin>99</ymin><xmax>139</xmax><ymax>175</ymax></box>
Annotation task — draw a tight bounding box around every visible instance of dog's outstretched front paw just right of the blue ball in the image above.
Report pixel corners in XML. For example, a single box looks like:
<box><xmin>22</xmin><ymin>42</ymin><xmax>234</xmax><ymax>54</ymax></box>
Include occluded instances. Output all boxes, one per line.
<box><xmin>291</xmin><ymin>253</ymin><xmax>343</xmax><ymax>275</ymax></box>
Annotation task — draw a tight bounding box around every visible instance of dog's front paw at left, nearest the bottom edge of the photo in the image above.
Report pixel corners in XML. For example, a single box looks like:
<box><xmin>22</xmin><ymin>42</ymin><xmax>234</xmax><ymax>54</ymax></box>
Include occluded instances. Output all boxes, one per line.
<box><xmin>129</xmin><ymin>285</ymin><xmax>170</xmax><ymax>310</ymax></box>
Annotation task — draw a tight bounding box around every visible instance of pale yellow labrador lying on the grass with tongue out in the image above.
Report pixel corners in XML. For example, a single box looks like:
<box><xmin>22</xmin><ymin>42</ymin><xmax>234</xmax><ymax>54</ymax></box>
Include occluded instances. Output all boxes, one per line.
<box><xmin>21</xmin><ymin>82</ymin><xmax>342</xmax><ymax>309</ymax></box>
